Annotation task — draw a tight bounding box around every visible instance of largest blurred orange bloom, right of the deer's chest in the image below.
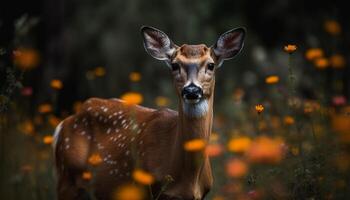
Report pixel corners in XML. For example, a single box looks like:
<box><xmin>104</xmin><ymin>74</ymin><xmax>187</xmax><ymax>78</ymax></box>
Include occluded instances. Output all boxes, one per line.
<box><xmin>246</xmin><ymin>136</ymin><xmax>283</xmax><ymax>164</ymax></box>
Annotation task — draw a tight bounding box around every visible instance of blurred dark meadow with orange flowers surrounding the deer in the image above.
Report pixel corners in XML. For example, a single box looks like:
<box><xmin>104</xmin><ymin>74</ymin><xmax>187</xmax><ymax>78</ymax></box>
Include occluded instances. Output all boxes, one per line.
<box><xmin>0</xmin><ymin>0</ymin><xmax>350</xmax><ymax>200</ymax></box>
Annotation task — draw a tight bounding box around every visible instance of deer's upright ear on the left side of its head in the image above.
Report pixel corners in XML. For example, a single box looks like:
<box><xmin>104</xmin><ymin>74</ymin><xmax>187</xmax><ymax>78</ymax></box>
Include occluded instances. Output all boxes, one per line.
<box><xmin>141</xmin><ymin>26</ymin><xmax>177</xmax><ymax>60</ymax></box>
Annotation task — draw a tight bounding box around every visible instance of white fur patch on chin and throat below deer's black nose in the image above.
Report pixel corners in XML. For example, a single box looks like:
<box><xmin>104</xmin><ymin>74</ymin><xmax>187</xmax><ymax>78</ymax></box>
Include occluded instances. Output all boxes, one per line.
<box><xmin>183</xmin><ymin>99</ymin><xmax>208</xmax><ymax>118</ymax></box>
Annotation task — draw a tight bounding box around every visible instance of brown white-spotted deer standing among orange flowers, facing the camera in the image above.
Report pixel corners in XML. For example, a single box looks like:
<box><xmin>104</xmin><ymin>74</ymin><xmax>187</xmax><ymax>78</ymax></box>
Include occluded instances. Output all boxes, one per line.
<box><xmin>53</xmin><ymin>26</ymin><xmax>246</xmax><ymax>200</ymax></box>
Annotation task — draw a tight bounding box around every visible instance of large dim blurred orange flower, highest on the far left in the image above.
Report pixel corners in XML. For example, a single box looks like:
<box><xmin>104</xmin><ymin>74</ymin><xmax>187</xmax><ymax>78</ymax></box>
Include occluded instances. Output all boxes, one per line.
<box><xmin>13</xmin><ymin>48</ymin><xmax>40</xmax><ymax>70</ymax></box>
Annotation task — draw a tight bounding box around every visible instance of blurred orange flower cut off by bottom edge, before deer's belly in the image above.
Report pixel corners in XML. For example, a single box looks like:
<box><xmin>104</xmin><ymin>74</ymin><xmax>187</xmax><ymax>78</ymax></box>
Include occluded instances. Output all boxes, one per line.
<box><xmin>113</xmin><ymin>184</ymin><xmax>145</xmax><ymax>200</ymax></box>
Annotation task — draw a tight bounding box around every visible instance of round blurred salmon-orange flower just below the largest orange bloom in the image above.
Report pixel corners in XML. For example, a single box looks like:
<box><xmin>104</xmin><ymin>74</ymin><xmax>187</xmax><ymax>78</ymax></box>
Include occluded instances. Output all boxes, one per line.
<box><xmin>226</xmin><ymin>158</ymin><xmax>248</xmax><ymax>178</ymax></box>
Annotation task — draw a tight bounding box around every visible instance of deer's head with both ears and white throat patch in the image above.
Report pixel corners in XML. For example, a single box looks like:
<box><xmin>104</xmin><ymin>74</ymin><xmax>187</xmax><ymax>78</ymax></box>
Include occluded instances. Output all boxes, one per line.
<box><xmin>141</xmin><ymin>26</ymin><xmax>245</xmax><ymax>118</ymax></box>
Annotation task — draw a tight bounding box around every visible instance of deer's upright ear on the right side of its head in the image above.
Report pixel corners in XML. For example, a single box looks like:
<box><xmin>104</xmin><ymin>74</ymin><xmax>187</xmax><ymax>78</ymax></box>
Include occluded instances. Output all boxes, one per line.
<box><xmin>212</xmin><ymin>28</ymin><xmax>246</xmax><ymax>63</ymax></box>
